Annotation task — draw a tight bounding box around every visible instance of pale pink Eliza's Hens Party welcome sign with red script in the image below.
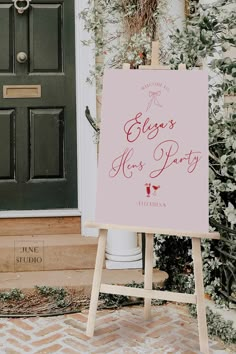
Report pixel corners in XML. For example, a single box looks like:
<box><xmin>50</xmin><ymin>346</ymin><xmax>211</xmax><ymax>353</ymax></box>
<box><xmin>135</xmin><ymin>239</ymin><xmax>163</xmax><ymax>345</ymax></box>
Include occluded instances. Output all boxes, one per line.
<box><xmin>96</xmin><ymin>70</ymin><xmax>208</xmax><ymax>232</ymax></box>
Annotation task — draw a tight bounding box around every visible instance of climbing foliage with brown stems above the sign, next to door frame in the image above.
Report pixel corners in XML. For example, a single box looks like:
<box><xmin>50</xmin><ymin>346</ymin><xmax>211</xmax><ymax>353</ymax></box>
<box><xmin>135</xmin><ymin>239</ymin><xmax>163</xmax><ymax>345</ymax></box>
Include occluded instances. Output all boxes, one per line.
<box><xmin>80</xmin><ymin>0</ymin><xmax>166</xmax><ymax>90</ymax></box>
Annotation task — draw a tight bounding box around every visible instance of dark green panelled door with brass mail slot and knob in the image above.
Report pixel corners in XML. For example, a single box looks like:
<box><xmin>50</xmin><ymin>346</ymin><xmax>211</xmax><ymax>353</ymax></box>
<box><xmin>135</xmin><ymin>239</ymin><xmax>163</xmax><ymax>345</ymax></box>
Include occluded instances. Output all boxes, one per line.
<box><xmin>0</xmin><ymin>0</ymin><xmax>77</xmax><ymax>210</ymax></box>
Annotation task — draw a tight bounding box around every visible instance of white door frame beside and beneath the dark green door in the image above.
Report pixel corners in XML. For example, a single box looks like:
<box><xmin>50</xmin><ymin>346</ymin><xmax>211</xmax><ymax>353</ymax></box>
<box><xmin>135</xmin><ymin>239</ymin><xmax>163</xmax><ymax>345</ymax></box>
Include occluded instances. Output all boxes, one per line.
<box><xmin>0</xmin><ymin>0</ymin><xmax>97</xmax><ymax>236</ymax></box>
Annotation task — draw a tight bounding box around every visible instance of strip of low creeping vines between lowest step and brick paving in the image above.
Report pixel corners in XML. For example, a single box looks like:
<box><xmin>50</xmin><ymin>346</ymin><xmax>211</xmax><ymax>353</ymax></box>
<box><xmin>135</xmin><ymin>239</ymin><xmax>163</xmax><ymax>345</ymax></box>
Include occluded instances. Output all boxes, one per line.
<box><xmin>0</xmin><ymin>284</ymin><xmax>146</xmax><ymax>318</ymax></box>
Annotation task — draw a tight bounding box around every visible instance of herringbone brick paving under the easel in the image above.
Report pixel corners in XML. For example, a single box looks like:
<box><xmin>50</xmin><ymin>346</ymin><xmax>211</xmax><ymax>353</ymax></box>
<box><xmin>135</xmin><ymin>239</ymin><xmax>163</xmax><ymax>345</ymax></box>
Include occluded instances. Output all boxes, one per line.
<box><xmin>0</xmin><ymin>304</ymin><xmax>229</xmax><ymax>354</ymax></box>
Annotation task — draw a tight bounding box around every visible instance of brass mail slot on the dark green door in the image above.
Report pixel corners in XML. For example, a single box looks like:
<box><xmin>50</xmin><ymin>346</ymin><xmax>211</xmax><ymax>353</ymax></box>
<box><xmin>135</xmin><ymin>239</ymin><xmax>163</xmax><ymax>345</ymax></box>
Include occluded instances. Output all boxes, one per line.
<box><xmin>3</xmin><ymin>85</ymin><xmax>41</xmax><ymax>98</ymax></box>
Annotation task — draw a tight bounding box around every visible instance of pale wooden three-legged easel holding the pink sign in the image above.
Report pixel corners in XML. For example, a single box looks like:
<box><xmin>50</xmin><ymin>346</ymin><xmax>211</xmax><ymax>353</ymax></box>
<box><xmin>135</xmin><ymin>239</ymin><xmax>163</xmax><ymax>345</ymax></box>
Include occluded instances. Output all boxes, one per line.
<box><xmin>85</xmin><ymin>42</ymin><xmax>220</xmax><ymax>354</ymax></box>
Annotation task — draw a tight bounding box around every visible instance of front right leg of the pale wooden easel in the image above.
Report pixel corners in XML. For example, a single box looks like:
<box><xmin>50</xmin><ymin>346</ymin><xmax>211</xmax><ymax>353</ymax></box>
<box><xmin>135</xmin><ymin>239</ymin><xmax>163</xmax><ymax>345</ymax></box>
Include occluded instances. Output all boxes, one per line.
<box><xmin>192</xmin><ymin>238</ymin><xmax>209</xmax><ymax>354</ymax></box>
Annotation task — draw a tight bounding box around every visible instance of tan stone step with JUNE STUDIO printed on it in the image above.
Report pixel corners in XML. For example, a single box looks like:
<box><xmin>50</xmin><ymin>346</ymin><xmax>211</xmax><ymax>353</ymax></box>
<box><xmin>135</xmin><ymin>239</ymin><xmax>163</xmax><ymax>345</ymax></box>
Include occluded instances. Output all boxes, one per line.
<box><xmin>0</xmin><ymin>234</ymin><xmax>97</xmax><ymax>272</ymax></box>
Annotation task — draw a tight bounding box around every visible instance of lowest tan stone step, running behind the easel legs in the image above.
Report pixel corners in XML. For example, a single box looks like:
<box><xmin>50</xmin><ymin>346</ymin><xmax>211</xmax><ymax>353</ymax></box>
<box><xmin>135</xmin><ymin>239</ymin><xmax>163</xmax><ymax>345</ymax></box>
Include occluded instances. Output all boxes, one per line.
<box><xmin>0</xmin><ymin>269</ymin><xmax>168</xmax><ymax>295</ymax></box>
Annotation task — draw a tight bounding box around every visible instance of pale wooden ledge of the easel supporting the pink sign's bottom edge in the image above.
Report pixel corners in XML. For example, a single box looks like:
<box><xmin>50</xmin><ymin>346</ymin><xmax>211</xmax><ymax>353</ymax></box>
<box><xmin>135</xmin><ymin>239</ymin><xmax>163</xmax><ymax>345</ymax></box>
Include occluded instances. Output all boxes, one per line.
<box><xmin>85</xmin><ymin>221</ymin><xmax>220</xmax><ymax>240</ymax></box>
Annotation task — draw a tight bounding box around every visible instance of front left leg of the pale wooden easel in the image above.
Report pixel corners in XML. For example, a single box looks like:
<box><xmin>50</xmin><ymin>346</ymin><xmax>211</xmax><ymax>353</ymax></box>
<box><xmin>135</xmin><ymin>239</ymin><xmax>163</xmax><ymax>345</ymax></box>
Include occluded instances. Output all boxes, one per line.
<box><xmin>86</xmin><ymin>230</ymin><xmax>107</xmax><ymax>337</ymax></box>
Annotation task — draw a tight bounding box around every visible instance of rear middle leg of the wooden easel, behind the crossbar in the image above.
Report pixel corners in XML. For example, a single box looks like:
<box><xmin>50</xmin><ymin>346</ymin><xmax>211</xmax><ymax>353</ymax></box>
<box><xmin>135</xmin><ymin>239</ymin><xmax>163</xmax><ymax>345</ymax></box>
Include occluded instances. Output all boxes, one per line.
<box><xmin>144</xmin><ymin>234</ymin><xmax>154</xmax><ymax>320</ymax></box>
